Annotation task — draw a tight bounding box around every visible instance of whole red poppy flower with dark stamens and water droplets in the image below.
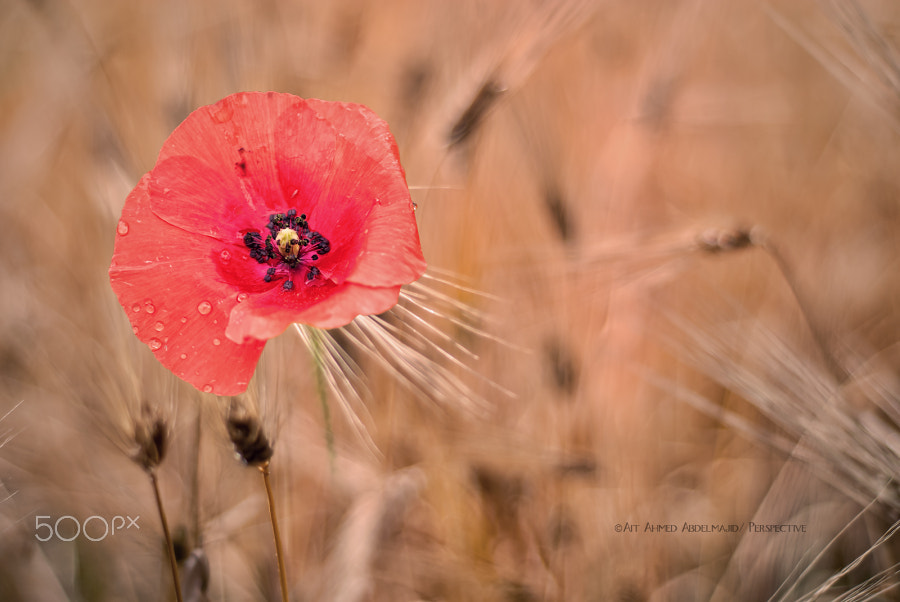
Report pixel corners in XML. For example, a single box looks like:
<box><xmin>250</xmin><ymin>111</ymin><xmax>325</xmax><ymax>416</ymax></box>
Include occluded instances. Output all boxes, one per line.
<box><xmin>109</xmin><ymin>92</ymin><xmax>425</xmax><ymax>395</ymax></box>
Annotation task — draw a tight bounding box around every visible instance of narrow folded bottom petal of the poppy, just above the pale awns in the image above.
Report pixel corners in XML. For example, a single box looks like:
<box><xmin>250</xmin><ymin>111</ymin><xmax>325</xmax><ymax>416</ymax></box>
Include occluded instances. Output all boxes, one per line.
<box><xmin>225</xmin><ymin>283</ymin><xmax>400</xmax><ymax>341</ymax></box>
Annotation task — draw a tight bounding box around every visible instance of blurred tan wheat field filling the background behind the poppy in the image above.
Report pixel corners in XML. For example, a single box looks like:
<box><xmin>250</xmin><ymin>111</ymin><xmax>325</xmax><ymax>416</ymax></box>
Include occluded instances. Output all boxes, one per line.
<box><xmin>0</xmin><ymin>0</ymin><xmax>900</xmax><ymax>602</ymax></box>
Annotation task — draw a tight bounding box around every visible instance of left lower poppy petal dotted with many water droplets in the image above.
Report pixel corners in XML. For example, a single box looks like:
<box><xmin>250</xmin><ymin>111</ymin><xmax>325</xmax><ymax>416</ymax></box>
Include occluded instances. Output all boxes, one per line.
<box><xmin>109</xmin><ymin>174</ymin><xmax>264</xmax><ymax>395</ymax></box>
